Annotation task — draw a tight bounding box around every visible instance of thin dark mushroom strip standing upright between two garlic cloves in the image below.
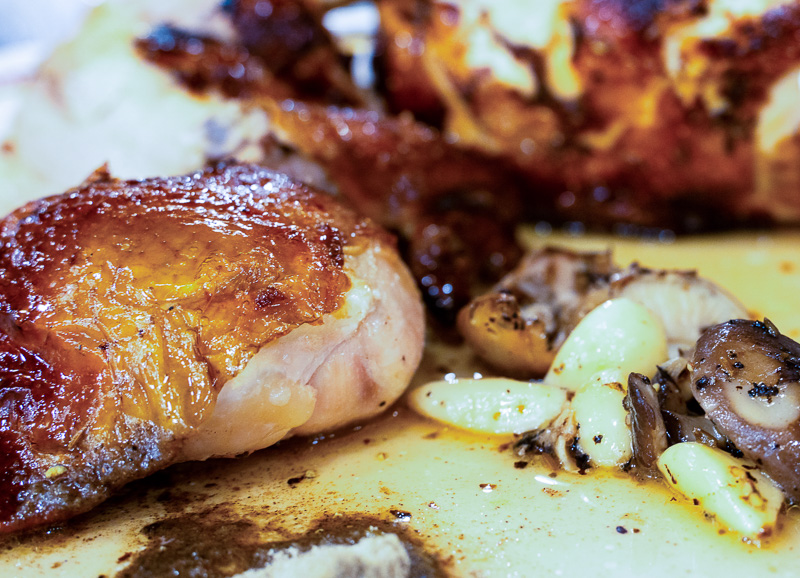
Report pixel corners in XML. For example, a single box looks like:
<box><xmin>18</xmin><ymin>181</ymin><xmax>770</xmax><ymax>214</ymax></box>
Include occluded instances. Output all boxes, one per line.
<box><xmin>623</xmin><ymin>373</ymin><xmax>667</xmax><ymax>478</ymax></box>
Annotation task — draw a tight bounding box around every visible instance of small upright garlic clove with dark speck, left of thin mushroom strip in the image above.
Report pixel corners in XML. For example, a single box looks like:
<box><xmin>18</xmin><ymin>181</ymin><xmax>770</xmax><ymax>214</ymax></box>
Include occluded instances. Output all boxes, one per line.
<box><xmin>572</xmin><ymin>382</ymin><xmax>633</xmax><ymax>467</ymax></box>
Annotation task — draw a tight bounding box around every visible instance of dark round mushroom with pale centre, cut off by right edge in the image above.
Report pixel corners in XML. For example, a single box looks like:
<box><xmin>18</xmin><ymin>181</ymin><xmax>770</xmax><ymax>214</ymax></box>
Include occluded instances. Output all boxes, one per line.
<box><xmin>692</xmin><ymin>319</ymin><xmax>800</xmax><ymax>503</ymax></box>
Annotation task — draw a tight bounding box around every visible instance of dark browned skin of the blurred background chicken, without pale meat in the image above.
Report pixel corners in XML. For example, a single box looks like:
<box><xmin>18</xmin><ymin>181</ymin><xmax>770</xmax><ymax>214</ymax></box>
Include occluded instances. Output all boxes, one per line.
<box><xmin>133</xmin><ymin>0</ymin><xmax>800</xmax><ymax>323</ymax></box>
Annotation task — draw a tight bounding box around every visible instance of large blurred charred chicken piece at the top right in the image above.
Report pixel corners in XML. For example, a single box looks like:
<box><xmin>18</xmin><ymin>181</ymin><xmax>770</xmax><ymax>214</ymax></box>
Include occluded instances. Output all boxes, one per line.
<box><xmin>378</xmin><ymin>0</ymin><xmax>800</xmax><ymax>230</ymax></box>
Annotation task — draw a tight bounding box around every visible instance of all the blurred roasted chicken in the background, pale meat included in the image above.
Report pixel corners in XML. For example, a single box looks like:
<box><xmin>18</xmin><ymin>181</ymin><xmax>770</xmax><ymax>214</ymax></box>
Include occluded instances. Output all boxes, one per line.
<box><xmin>0</xmin><ymin>0</ymin><xmax>800</xmax><ymax>322</ymax></box>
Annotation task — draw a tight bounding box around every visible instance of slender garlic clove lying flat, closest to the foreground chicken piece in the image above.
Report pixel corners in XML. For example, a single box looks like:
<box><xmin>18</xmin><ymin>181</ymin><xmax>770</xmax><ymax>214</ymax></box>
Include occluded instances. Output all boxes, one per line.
<box><xmin>408</xmin><ymin>378</ymin><xmax>567</xmax><ymax>434</ymax></box>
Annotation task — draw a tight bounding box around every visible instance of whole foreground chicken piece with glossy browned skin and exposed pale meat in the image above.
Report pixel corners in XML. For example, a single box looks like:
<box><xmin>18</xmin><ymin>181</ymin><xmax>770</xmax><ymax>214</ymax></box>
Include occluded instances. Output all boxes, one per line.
<box><xmin>0</xmin><ymin>163</ymin><xmax>423</xmax><ymax>531</ymax></box>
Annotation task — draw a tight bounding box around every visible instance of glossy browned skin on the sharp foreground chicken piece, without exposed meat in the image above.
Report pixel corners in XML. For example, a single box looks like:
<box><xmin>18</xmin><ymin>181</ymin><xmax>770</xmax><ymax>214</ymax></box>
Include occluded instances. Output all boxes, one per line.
<box><xmin>0</xmin><ymin>164</ymin><xmax>387</xmax><ymax>531</ymax></box>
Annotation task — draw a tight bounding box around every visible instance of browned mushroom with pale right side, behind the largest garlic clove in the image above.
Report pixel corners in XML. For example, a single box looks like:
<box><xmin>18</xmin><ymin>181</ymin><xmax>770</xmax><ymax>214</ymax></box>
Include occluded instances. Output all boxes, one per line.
<box><xmin>458</xmin><ymin>247</ymin><xmax>747</xmax><ymax>377</ymax></box>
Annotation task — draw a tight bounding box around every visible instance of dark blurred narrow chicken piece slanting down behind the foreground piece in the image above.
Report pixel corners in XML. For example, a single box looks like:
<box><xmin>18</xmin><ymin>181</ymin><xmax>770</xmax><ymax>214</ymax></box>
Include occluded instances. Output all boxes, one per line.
<box><xmin>137</xmin><ymin>18</ymin><xmax>521</xmax><ymax>323</ymax></box>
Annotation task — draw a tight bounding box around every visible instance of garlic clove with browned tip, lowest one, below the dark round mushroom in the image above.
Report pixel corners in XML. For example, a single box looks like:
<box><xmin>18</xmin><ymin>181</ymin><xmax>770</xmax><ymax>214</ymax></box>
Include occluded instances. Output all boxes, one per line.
<box><xmin>658</xmin><ymin>442</ymin><xmax>784</xmax><ymax>542</ymax></box>
